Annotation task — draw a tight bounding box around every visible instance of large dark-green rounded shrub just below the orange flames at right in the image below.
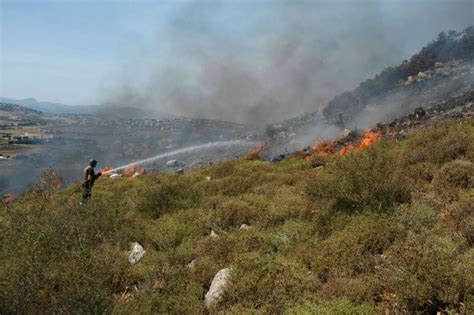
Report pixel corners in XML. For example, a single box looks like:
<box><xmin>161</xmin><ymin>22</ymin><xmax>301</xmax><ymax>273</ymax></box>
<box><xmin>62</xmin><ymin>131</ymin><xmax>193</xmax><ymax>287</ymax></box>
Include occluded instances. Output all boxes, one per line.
<box><xmin>307</xmin><ymin>145</ymin><xmax>411</xmax><ymax>212</ymax></box>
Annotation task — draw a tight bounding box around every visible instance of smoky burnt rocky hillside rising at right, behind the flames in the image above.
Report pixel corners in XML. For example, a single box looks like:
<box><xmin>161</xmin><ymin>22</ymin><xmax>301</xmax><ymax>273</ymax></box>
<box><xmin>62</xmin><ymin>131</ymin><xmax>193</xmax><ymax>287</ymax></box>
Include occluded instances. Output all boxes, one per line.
<box><xmin>265</xmin><ymin>26</ymin><xmax>474</xmax><ymax>158</ymax></box>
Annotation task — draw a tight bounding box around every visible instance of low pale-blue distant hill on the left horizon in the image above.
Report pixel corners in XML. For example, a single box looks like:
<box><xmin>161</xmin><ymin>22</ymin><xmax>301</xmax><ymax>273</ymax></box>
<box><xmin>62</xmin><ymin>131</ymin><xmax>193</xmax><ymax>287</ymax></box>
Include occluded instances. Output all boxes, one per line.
<box><xmin>0</xmin><ymin>97</ymin><xmax>174</xmax><ymax>119</ymax></box>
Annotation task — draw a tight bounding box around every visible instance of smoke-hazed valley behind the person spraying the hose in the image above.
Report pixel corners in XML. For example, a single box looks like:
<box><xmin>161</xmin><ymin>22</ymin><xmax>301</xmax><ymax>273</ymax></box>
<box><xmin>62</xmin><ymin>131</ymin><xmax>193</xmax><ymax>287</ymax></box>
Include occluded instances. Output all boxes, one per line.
<box><xmin>0</xmin><ymin>103</ymin><xmax>259</xmax><ymax>196</ymax></box>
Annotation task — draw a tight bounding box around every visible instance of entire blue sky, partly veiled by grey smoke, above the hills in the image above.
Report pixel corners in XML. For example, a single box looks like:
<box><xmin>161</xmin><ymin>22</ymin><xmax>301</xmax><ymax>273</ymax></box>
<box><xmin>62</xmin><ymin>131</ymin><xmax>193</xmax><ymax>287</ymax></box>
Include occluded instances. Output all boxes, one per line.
<box><xmin>0</xmin><ymin>0</ymin><xmax>474</xmax><ymax>122</ymax></box>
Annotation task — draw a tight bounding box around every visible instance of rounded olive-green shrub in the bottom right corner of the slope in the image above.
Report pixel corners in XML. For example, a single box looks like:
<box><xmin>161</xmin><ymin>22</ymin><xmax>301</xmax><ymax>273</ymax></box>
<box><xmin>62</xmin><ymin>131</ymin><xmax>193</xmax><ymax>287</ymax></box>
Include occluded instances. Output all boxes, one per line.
<box><xmin>381</xmin><ymin>234</ymin><xmax>466</xmax><ymax>313</ymax></box>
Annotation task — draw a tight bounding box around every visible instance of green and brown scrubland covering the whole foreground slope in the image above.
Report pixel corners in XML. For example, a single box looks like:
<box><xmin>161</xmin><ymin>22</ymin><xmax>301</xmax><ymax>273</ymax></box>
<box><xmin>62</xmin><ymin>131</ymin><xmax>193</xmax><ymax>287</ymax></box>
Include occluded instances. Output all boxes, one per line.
<box><xmin>0</xmin><ymin>121</ymin><xmax>474</xmax><ymax>314</ymax></box>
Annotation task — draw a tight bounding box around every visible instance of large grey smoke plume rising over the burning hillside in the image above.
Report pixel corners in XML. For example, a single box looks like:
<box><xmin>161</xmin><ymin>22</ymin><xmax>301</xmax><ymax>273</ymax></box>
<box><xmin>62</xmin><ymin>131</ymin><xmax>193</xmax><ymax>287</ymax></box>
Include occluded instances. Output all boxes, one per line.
<box><xmin>101</xmin><ymin>0</ymin><xmax>473</xmax><ymax>126</ymax></box>
